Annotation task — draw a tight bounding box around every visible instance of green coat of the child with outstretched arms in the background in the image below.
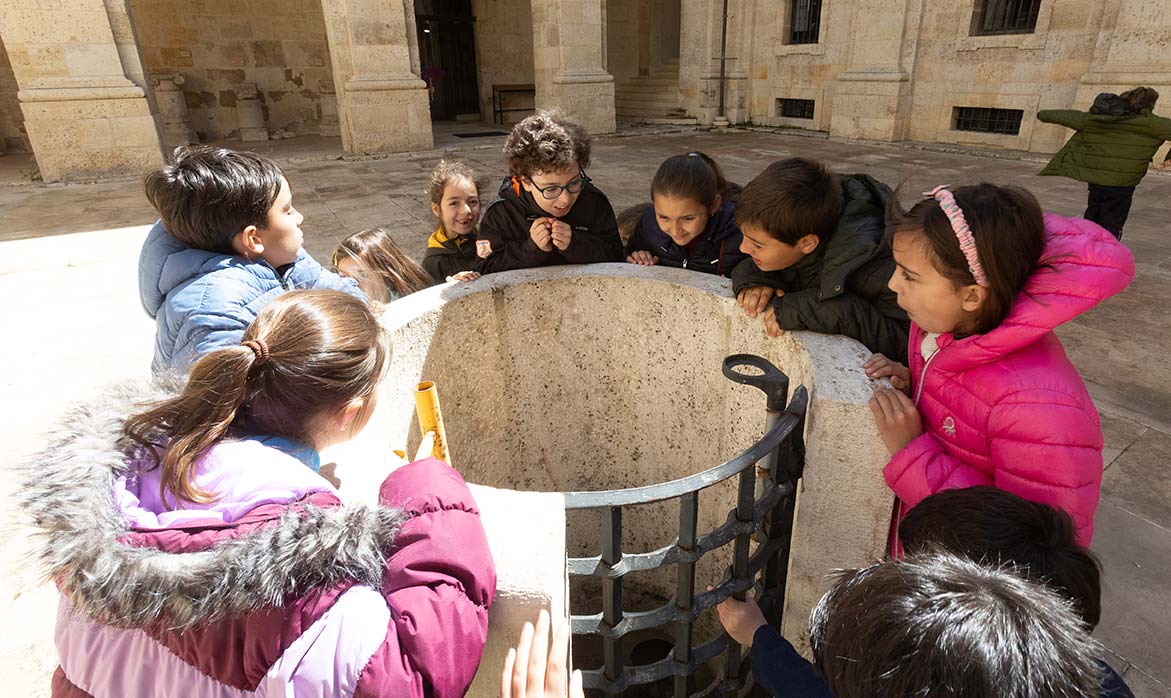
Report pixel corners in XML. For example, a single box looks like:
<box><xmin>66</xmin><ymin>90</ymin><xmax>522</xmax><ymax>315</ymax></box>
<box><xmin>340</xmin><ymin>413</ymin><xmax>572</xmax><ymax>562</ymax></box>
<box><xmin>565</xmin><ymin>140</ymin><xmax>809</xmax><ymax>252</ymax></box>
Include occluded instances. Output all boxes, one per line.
<box><xmin>1036</xmin><ymin>109</ymin><xmax>1171</xmax><ymax>186</ymax></box>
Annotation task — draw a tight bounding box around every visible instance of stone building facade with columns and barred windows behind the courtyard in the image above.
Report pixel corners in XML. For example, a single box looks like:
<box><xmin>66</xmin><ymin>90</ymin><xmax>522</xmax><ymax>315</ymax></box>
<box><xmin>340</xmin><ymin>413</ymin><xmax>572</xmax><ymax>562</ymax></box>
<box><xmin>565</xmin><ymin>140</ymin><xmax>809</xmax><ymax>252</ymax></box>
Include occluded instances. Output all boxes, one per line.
<box><xmin>0</xmin><ymin>0</ymin><xmax>1171</xmax><ymax>180</ymax></box>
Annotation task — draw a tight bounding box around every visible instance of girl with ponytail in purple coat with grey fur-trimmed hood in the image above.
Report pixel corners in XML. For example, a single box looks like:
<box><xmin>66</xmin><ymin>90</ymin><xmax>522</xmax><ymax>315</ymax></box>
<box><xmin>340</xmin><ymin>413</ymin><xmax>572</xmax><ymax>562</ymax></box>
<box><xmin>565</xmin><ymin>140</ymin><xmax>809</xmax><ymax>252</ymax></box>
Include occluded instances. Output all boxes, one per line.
<box><xmin>22</xmin><ymin>290</ymin><xmax>495</xmax><ymax>698</ymax></box>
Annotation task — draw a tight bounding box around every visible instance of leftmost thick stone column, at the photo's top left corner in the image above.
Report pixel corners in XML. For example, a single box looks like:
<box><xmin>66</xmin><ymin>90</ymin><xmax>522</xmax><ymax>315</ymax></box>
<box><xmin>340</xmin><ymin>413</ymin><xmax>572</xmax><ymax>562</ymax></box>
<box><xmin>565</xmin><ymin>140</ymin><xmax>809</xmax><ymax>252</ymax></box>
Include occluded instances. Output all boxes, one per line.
<box><xmin>0</xmin><ymin>0</ymin><xmax>163</xmax><ymax>182</ymax></box>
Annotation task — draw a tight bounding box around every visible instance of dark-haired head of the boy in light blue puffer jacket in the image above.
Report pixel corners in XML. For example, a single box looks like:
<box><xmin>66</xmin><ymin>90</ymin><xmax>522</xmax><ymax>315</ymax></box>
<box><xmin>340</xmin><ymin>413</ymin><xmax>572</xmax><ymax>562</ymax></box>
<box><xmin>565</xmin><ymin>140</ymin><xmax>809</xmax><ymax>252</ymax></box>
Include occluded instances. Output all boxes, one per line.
<box><xmin>144</xmin><ymin>145</ymin><xmax>304</xmax><ymax>268</ymax></box>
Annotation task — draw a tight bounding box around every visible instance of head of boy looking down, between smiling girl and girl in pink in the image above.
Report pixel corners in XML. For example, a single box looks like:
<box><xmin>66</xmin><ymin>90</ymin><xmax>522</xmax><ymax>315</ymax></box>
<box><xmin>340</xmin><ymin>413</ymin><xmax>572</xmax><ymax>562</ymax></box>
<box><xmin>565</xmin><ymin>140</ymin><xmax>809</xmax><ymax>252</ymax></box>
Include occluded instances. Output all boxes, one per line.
<box><xmin>735</xmin><ymin>158</ymin><xmax>842</xmax><ymax>272</ymax></box>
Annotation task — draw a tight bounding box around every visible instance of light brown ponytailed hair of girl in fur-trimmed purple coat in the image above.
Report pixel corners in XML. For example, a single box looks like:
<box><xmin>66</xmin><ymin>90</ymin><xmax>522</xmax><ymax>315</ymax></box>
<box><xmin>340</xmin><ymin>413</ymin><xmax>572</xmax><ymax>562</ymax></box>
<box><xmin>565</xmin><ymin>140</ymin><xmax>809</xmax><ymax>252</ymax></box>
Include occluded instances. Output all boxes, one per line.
<box><xmin>123</xmin><ymin>290</ymin><xmax>391</xmax><ymax>504</ymax></box>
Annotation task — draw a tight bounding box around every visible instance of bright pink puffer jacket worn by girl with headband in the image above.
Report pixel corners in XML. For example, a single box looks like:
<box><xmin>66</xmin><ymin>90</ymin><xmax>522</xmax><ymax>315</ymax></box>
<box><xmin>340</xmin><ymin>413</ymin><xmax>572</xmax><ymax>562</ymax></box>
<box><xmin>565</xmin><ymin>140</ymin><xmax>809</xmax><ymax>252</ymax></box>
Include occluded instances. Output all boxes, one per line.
<box><xmin>883</xmin><ymin>214</ymin><xmax>1135</xmax><ymax>546</ymax></box>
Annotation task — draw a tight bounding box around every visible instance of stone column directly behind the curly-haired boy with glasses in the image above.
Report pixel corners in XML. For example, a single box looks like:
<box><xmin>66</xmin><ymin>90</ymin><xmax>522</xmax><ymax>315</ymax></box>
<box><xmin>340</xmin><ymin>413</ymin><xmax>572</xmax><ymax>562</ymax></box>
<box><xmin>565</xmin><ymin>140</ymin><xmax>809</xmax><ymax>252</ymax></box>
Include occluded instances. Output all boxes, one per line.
<box><xmin>532</xmin><ymin>0</ymin><xmax>616</xmax><ymax>134</ymax></box>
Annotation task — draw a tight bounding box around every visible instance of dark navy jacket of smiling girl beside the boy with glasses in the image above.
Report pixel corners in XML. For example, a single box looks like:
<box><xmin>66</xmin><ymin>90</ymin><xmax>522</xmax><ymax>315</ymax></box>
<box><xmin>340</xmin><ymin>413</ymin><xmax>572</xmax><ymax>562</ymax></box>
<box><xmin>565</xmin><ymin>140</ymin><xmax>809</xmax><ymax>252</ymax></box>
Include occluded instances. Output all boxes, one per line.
<box><xmin>625</xmin><ymin>201</ymin><xmax>748</xmax><ymax>276</ymax></box>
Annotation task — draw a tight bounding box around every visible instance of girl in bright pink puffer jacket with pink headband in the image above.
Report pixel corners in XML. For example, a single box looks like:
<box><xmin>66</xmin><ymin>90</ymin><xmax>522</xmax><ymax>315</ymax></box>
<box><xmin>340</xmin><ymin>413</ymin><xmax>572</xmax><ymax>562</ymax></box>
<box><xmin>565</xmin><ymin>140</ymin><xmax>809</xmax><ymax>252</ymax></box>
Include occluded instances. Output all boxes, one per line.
<box><xmin>865</xmin><ymin>184</ymin><xmax>1135</xmax><ymax>555</ymax></box>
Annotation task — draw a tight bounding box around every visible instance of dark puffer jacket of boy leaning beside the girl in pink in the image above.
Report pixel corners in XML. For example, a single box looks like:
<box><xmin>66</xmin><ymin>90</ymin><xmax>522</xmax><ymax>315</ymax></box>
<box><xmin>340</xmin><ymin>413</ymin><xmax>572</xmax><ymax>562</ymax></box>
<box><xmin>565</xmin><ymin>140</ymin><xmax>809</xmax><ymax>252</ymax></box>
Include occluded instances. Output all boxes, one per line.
<box><xmin>732</xmin><ymin>175</ymin><xmax>911</xmax><ymax>363</ymax></box>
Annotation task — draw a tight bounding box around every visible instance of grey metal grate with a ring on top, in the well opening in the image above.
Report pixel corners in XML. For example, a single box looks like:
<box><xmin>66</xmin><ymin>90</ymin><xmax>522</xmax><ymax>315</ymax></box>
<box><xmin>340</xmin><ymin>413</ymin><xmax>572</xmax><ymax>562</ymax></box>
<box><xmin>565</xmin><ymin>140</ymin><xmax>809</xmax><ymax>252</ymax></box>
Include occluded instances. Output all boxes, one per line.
<box><xmin>566</xmin><ymin>354</ymin><xmax>809</xmax><ymax>698</ymax></box>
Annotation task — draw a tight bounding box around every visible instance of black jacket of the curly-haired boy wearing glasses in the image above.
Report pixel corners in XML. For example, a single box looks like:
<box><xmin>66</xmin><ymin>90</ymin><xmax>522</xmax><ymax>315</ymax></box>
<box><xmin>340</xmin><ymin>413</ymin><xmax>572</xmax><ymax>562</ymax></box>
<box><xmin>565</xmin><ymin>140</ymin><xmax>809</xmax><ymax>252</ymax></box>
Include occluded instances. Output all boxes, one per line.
<box><xmin>478</xmin><ymin>178</ymin><xmax>622</xmax><ymax>274</ymax></box>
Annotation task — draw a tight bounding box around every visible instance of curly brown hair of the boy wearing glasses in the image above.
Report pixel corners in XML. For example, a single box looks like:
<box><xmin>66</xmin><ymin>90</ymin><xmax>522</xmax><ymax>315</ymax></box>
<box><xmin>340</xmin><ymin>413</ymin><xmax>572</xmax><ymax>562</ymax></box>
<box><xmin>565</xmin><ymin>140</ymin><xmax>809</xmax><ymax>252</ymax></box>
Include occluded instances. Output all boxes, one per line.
<box><xmin>505</xmin><ymin>110</ymin><xmax>590</xmax><ymax>177</ymax></box>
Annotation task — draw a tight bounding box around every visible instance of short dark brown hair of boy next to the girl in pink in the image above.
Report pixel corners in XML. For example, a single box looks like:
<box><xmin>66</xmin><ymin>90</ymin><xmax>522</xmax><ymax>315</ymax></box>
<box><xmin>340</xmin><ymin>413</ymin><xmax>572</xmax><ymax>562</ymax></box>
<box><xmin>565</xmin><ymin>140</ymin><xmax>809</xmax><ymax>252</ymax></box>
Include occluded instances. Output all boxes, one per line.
<box><xmin>735</xmin><ymin>158</ymin><xmax>842</xmax><ymax>245</ymax></box>
